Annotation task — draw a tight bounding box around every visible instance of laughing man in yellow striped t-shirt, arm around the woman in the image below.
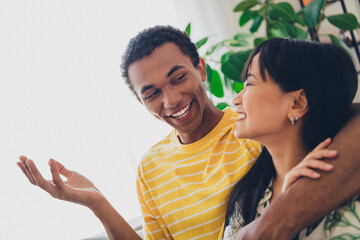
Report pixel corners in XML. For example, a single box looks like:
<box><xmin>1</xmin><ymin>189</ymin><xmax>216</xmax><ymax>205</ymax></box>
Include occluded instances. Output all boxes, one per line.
<box><xmin>18</xmin><ymin>26</ymin><xmax>360</xmax><ymax>239</ymax></box>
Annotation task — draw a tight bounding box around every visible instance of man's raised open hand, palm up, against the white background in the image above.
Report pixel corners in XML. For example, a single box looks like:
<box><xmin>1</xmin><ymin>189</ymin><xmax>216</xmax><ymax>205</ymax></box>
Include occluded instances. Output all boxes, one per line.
<box><xmin>17</xmin><ymin>156</ymin><xmax>104</xmax><ymax>209</ymax></box>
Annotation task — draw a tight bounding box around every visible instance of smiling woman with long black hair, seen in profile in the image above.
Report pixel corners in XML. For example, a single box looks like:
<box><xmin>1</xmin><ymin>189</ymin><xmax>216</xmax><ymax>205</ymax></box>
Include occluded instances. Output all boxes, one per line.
<box><xmin>224</xmin><ymin>39</ymin><xmax>360</xmax><ymax>239</ymax></box>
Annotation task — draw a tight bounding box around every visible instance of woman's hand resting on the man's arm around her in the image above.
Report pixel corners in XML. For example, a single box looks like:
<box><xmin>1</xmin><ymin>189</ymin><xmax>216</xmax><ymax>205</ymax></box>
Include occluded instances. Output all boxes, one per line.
<box><xmin>282</xmin><ymin>138</ymin><xmax>337</xmax><ymax>192</ymax></box>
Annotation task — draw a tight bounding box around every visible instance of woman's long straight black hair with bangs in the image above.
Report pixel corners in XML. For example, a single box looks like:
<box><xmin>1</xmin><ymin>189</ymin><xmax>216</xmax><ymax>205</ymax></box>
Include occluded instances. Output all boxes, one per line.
<box><xmin>225</xmin><ymin>39</ymin><xmax>358</xmax><ymax>226</ymax></box>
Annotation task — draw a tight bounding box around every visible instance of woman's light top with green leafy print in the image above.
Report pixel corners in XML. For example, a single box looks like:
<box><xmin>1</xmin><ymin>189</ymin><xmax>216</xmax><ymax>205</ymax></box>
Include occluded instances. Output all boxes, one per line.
<box><xmin>223</xmin><ymin>180</ymin><xmax>360</xmax><ymax>240</ymax></box>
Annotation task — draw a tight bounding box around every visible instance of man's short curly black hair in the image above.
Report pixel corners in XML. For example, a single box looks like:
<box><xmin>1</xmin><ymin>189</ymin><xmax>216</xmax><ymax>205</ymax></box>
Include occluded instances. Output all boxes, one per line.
<box><xmin>120</xmin><ymin>26</ymin><xmax>199</xmax><ymax>101</ymax></box>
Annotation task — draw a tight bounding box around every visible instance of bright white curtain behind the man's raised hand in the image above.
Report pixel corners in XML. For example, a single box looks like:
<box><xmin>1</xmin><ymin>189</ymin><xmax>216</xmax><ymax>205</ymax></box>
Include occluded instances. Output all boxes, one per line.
<box><xmin>0</xmin><ymin>0</ymin><xmax>242</xmax><ymax>240</ymax></box>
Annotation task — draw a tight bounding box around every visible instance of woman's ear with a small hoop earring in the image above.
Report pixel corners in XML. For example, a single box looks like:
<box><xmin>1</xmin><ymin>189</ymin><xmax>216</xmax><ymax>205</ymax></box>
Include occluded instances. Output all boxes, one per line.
<box><xmin>288</xmin><ymin>89</ymin><xmax>309</xmax><ymax>119</ymax></box>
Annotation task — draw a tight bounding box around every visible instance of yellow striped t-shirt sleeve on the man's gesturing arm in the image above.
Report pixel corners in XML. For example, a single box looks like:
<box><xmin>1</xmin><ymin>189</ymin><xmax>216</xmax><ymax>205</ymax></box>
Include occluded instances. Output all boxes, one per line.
<box><xmin>136</xmin><ymin>168</ymin><xmax>170</xmax><ymax>240</ymax></box>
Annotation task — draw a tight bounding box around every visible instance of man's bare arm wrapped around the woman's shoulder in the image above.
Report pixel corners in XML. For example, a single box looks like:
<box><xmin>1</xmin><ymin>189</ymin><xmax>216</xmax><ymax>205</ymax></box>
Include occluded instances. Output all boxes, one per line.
<box><xmin>238</xmin><ymin>104</ymin><xmax>360</xmax><ymax>240</ymax></box>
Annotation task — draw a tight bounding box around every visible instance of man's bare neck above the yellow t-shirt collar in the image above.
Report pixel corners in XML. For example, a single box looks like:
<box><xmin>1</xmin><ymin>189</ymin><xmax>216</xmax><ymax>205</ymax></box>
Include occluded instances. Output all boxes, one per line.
<box><xmin>179</xmin><ymin>103</ymin><xmax>224</xmax><ymax>144</ymax></box>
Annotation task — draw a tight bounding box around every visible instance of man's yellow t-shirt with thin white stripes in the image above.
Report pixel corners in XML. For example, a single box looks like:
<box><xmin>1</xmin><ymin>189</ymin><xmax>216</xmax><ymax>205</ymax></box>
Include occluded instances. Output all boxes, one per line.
<box><xmin>137</xmin><ymin>108</ymin><xmax>261</xmax><ymax>240</ymax></box>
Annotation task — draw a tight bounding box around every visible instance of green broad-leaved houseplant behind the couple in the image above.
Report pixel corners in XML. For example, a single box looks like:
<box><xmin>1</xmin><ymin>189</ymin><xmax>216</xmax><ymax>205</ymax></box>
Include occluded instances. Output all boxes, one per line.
<box><xmin>185</xmin><ymin>0</ymin><xmax>359</xmax><ymax>109</ymax></box>
